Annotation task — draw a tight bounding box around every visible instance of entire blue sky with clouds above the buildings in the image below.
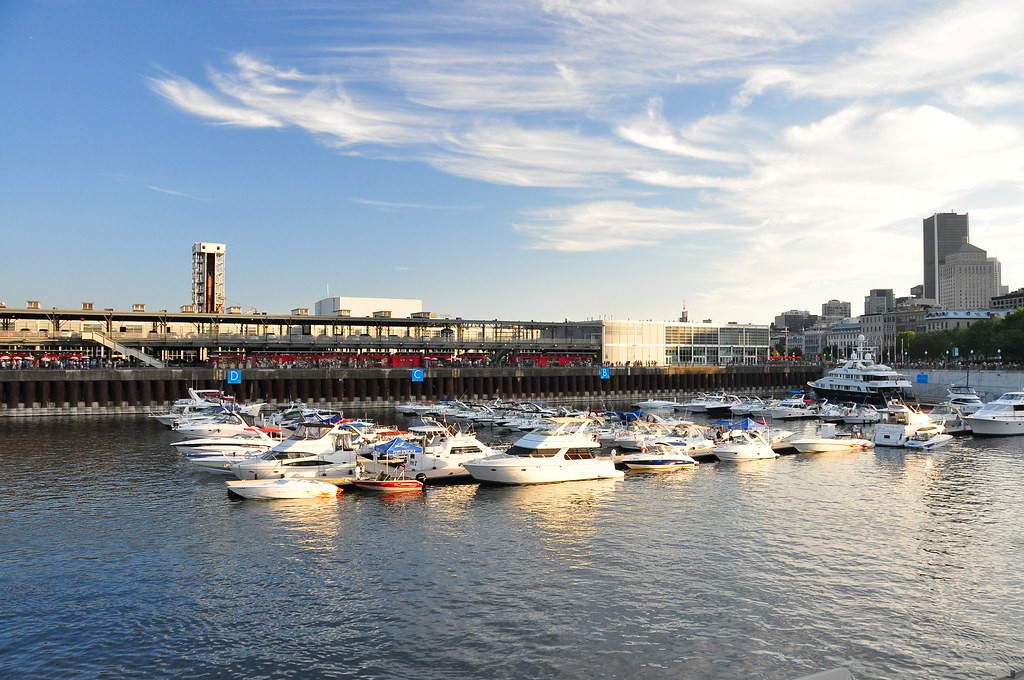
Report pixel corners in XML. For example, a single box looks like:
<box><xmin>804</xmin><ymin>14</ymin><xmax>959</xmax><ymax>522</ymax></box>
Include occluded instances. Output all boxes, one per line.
<box><xmin>0</xmin><ymin>0</ymin><xmax>1024</xmax><ymax>324</ymax></box>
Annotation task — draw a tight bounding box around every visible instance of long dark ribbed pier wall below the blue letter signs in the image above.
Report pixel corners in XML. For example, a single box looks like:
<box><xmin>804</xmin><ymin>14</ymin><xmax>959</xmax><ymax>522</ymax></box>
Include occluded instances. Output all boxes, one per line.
<box><xmin>0</xmin><ymin>364</ymin><xmax>822</xmax><ymax>417</ymax></box>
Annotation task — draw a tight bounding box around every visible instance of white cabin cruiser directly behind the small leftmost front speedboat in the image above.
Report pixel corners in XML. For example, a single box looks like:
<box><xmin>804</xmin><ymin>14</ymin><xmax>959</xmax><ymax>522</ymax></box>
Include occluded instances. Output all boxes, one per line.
<box><xmin>231</xmin><ymin>421</ymin><xmax>360</xmax><ymax>483</ymax></box>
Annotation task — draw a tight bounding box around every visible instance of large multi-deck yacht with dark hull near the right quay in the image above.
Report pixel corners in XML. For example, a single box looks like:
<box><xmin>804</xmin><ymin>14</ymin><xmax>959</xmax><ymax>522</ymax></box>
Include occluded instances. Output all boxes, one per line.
<box><xmin>807</xmin><ymin>335</ymin><xmax>913</xmax><ymax>406</ymax></box>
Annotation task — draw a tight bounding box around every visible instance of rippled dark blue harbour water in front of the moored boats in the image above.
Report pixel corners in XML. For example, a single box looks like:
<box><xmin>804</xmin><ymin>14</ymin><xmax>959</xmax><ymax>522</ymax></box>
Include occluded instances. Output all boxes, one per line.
<box><xmin>0</xmin><ymin>411</ymin><xmax>1024</xmax><ymax>680</ymax></box>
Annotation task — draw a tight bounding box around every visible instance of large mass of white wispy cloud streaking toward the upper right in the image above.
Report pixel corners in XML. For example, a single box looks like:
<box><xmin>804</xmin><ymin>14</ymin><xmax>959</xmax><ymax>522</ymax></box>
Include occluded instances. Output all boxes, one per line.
<box><xmin>151</xmin><ymin>0</ymin><xmax>1024</xmax><ymax>292</ymax></box>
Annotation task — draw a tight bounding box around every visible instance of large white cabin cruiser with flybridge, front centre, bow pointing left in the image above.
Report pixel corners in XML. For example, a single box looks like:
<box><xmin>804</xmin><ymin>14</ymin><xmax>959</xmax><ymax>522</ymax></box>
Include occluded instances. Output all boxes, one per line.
<box><xmin>464</xmin><ymin>418</ymin><xmax>625</xmax><ymax>484</ymax></box>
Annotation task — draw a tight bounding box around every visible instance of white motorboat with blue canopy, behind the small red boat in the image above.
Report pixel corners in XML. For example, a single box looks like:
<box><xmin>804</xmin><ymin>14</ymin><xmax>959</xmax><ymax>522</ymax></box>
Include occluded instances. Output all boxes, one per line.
<box><xmin>359</xmin><ymin>419</ymin><xmax>498</xmax><ymax>482</ymax></box>
